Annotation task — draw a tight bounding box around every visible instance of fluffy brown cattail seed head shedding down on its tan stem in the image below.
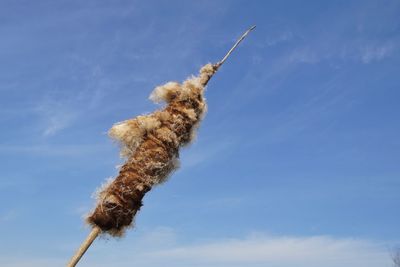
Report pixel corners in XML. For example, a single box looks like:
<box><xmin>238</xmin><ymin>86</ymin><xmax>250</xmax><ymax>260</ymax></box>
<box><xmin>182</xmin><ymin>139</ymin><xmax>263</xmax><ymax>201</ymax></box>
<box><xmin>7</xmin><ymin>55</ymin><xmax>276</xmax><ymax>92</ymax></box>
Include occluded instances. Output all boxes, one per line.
<box><xmin>68</xmin><ymin>26</ymin><xmax>255</xmax><ymax>266</ymax></box>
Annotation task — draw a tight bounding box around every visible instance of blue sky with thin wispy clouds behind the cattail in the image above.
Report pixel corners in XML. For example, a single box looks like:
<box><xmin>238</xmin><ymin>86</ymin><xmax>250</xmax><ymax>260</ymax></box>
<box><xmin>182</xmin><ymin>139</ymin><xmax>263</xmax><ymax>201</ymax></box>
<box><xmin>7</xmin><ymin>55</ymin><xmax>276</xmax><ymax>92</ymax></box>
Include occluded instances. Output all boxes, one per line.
<box><xmin>0</xmin><ymin>0</ymin><xmax>400</xmax><ymax>267</ymax></box>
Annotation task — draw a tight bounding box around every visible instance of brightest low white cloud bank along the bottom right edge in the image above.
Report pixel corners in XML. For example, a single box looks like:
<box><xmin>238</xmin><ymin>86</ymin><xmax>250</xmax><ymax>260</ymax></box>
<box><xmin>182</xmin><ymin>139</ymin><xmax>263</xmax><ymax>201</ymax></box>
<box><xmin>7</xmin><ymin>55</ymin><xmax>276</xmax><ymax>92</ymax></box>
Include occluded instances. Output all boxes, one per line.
<box><xmin>144</xmin><ymin>236</ymin><xmax>390</xmax><ymax>267</ymax></box>
